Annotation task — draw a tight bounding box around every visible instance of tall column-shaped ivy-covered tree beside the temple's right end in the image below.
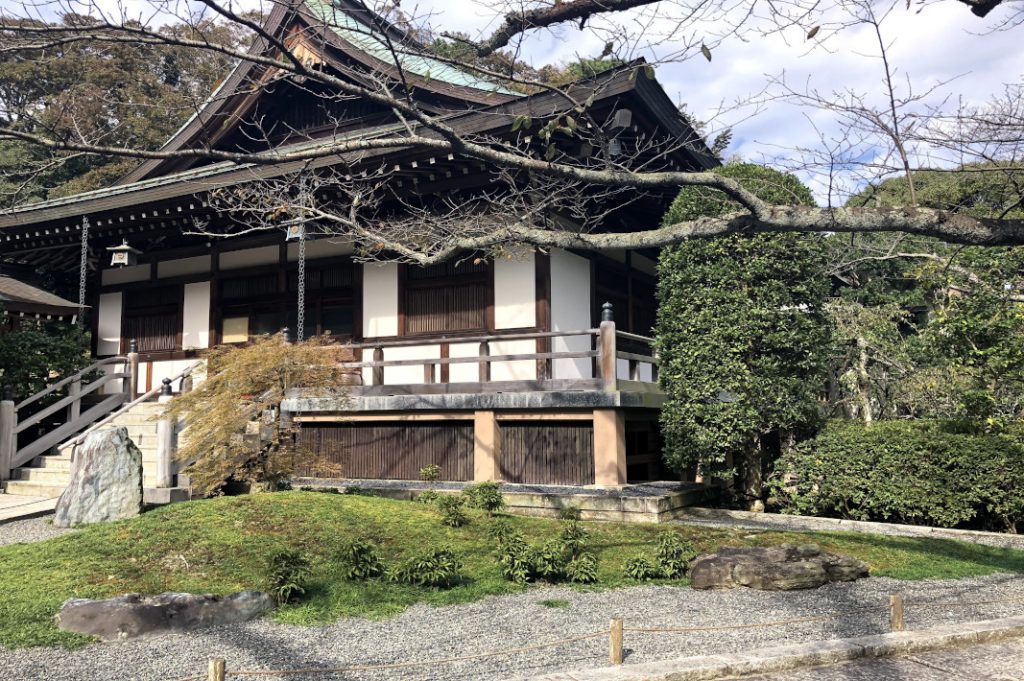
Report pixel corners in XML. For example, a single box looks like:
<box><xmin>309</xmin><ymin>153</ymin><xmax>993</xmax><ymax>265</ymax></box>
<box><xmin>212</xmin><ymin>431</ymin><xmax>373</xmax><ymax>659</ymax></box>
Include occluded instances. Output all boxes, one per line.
<box><xmin>656</xmin><ymin>164</ymin><xmax>830</xmax><ymax>506</ymax></box>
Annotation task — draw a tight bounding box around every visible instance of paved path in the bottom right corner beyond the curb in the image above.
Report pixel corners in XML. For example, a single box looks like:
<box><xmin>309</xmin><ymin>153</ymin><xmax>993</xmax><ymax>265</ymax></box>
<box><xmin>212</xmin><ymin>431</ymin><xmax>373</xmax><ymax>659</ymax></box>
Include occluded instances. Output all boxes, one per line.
<box><xmin>743</xmin><ymin>639</ymin><xmax>1024</xmax><ymax>681</ymax></box>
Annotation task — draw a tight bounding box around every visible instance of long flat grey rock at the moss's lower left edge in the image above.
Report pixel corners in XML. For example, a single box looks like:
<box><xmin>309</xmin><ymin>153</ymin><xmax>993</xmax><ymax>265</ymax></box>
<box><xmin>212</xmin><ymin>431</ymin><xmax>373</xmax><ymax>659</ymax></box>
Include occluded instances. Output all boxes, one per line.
<box><xmin>56</xmin><ymin>591</ymin><xmax>273</xmax><ymax>641</ymax></box>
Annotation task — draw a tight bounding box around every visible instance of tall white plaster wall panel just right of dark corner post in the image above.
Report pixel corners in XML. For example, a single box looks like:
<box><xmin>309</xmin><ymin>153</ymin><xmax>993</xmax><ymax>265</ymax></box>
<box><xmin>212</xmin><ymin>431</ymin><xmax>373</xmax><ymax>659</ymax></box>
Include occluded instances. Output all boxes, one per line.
<box><xmin>551</xmin><ymin>250</ymin><xmax>593</xmax><ymax>379</ymax></box>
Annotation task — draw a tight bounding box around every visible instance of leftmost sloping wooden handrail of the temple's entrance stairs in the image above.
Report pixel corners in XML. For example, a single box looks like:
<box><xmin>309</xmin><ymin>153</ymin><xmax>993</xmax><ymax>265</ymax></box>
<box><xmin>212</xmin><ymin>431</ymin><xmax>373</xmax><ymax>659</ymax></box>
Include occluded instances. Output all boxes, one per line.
<box><xmin>0</xmin><ymin>341</ymin><xmax>138</xmax><ymax>480</ymax></box>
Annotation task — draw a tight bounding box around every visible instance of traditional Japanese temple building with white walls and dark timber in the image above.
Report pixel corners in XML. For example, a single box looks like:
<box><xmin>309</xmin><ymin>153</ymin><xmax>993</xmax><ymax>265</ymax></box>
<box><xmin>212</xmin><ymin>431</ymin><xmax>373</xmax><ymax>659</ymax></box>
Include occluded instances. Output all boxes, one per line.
<box><xmin>0</xmin><ymin>0</ymin><xmax>716</xmax><ymax>494</ymax></box>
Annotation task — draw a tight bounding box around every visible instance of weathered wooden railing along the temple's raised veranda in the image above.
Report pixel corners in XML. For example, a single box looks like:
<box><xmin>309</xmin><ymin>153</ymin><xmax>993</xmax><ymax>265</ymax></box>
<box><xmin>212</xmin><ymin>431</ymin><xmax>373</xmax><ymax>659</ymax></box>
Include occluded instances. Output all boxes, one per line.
<box><xmin>342</xmin><ymin>303</ymin><xmax>658</xmax><ymax>392</ymax></box>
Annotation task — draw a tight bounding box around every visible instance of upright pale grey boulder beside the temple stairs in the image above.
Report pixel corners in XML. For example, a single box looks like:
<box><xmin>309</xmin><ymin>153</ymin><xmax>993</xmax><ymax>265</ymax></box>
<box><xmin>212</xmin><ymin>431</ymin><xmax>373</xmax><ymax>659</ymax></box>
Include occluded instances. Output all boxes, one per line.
<box><xmin>53</xmin><ymin>428</ymin><xmax>142</xmax><ymax>527</ymax></box>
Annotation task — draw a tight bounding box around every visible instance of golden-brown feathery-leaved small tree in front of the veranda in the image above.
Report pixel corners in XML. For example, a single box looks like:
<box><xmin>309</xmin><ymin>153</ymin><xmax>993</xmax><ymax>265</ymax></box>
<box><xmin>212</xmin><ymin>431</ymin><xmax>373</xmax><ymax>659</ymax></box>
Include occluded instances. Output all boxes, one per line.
<box><xmin>161</xmin><ymin>335</ymin><xmax>351</xmax><ymax>495</ymax></box>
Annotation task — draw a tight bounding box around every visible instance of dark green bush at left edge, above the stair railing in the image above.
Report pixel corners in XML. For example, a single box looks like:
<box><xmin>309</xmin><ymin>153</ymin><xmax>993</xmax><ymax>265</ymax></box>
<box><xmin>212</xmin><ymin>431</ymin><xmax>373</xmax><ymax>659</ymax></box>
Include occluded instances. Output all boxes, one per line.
<box><xmin>0</xmin><ymin>319</ymin><xmax>95</xmax><ymax>399</ymax></box>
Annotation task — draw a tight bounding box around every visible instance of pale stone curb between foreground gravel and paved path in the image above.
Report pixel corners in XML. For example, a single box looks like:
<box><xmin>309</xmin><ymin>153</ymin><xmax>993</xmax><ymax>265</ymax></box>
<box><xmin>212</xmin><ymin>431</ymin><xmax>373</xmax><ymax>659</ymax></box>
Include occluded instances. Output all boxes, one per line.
<box><xmin>530</xmin><ymin>616</ymin><xmax>1024</xmax><ymax>681</ymax></box>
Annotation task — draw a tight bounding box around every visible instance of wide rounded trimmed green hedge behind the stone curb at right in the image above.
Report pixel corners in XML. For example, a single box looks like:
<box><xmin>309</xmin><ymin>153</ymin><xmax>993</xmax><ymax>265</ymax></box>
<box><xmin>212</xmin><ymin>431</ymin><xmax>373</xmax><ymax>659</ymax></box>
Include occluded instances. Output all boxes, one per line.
<box><xmin>770</xmin><ymin>421</ymin><xmax>1024</xmax><ymax>533</ymax></box>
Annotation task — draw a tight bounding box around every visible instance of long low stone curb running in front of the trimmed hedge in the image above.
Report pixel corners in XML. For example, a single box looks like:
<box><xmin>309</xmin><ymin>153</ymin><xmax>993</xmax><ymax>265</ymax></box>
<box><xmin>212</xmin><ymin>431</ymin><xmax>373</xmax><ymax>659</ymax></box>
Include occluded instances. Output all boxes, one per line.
<box><xmin>673</xmin><ymin>506</ymin><xmax>1024</xmax><ymax>549</ymax></box>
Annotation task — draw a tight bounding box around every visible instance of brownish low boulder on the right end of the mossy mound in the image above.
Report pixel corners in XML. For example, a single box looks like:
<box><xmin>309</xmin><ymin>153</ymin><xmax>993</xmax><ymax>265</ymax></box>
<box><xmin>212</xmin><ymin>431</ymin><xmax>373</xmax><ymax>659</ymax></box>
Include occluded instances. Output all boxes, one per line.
<box><xmin>690</xmin><ymin>544</ymin><xmax>868</xmax><ymax>591</ymax></box>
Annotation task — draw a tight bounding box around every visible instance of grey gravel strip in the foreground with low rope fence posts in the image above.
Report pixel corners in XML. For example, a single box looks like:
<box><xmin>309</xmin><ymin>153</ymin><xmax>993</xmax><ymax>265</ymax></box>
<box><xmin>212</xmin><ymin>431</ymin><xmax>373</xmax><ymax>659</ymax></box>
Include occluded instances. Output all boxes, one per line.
<box><xmin>0</xmin><ymin>574</ymin><xmax>1024</xmax><ymax>681</ymax></box>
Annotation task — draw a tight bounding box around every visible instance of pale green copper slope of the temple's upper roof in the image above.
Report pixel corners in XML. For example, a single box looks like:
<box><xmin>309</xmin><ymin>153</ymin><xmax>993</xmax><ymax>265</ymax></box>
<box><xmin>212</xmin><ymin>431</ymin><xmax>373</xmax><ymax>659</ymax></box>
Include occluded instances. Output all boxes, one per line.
<box><xmin>305</xmin><ymin>0</ymin><xmax>521</xmax><ymax>94</ymax></box>
